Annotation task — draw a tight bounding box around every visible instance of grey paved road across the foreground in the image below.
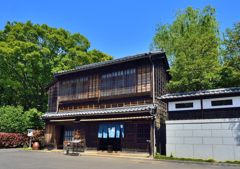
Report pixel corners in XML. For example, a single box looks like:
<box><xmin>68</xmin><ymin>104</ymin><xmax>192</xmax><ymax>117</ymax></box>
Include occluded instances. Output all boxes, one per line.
<box><xmin>0</xmin><ymin>149</ymin><xmax>237</xmax><ymax>169</ymax></box>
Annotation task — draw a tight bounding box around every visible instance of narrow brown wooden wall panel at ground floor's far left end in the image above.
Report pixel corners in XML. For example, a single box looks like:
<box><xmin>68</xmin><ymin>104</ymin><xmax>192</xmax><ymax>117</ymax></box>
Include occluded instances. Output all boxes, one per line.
<box><xmin>44</xmin><ymin>123</ymin><xmax>55</xmax><ymax>145</ymax></box>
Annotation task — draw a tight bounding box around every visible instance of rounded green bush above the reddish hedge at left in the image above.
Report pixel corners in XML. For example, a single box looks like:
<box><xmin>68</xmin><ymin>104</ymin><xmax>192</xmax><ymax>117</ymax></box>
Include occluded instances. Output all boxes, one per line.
<box><xmin>0</xmin><ymin>106</ymin><xmax>44</xmax><ymax>133</ymax></box>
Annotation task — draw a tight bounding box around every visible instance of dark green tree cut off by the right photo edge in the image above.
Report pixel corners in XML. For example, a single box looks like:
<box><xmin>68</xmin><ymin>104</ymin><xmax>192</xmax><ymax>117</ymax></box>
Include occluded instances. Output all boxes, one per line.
<box><xmin>218</xmin><ymin>21</ymin><xmax>240</xmax><ymax>87</ymax></box>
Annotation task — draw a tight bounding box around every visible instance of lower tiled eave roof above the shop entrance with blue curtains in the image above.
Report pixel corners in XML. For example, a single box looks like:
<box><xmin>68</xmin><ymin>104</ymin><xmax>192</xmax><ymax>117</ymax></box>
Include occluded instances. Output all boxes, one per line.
<box><xmin>42</xmin><ymin>104</ymin><xmax>153</xmax><ymax>118</ymax></box>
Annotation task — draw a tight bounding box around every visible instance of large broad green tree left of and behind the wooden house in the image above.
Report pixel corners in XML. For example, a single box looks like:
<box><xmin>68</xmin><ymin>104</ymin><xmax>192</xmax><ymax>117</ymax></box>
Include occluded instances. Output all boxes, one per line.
<box><xmin>0</xmin><ymin>21</ymin><xmax>113</xmax><ymax>112</ymax></box>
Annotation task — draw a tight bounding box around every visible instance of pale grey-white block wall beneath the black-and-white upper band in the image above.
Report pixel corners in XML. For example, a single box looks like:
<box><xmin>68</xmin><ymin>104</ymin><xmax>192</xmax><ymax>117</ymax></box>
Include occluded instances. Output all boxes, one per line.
<box><xmin>166</xmin><ymin>118</ymin><xmax>240</xmax><ymax>161</ymax></box>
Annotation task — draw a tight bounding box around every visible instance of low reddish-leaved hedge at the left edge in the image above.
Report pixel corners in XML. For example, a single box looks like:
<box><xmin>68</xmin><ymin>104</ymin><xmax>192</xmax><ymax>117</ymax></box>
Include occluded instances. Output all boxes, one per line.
<box><xmin>0</xmin><ymin>133</ymin><xmax>28</xmax><ymax>148</ymax></box>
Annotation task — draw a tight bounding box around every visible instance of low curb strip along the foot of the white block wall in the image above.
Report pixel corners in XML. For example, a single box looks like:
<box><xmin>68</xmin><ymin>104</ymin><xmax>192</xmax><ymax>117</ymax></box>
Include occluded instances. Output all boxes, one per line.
<box><xmin>153</xmin><ymin>159</ymin><xmax>240</xmax><ymax>167</ymax></box>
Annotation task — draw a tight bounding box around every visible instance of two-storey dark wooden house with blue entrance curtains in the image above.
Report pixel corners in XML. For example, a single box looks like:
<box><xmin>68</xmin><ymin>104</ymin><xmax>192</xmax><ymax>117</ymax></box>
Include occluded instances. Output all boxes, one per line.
<box><xmin>42</xmin><ymin>50</ymin><xmax>169</xmax><ymax>153</ymax></box>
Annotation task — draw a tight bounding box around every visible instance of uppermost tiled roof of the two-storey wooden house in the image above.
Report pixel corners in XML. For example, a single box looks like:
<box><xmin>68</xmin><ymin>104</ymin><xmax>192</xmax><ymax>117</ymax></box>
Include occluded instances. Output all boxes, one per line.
<box><xmin>54</xmin><ymin>49</ymin><xmax>165</xmax><ymax>75</ymax></box>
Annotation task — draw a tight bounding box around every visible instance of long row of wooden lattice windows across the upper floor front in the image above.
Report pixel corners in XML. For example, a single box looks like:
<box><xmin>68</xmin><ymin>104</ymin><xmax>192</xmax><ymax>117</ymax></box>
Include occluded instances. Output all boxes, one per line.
<box><xmin>56</xmin><ymin>64</ymin><xmax>151</xmax><ymax>102</ymax></box>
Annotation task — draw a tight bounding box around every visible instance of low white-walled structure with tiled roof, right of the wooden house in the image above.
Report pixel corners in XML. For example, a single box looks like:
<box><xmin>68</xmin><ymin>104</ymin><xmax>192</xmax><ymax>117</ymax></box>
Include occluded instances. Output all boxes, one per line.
<box><xmin>158</xmin><ymin>87</ymin><xmax>240</xmax><ymax>161</ymax></box>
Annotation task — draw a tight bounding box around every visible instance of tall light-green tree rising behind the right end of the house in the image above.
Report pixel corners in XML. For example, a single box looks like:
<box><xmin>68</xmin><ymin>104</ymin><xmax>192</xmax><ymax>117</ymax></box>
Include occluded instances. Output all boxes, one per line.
<box><xmin>150</xmin><ymin>6</ymin><xmax>221</xmax><ymax>92</ymax></box>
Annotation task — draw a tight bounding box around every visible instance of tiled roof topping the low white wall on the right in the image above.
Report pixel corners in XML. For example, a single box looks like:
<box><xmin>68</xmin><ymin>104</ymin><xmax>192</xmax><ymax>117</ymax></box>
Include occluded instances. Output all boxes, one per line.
<box><xmin>158</xmin><ymin>87</ymin><xmax>240</xmax><ymax>100</ymax></box>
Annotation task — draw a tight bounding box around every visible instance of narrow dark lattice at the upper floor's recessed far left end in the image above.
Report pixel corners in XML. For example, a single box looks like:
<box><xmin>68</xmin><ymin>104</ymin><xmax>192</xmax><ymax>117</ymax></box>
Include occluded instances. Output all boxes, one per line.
<box><xmin>48</xmin><ymin>82</ymin><xmax>58</xmax><ymax>112</ymax></box>
